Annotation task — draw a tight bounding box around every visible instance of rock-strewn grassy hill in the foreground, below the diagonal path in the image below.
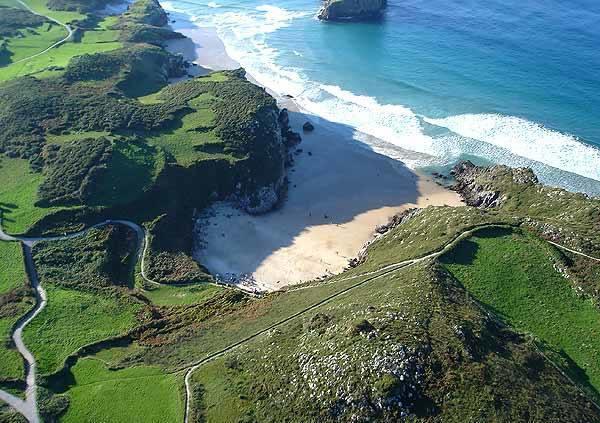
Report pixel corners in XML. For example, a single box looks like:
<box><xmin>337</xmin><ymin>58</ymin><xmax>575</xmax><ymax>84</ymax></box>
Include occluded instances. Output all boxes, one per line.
<box><xmin>192</xmin><ymin>264</ymin><xmax>598</xmax><ymax>422</ymax></box>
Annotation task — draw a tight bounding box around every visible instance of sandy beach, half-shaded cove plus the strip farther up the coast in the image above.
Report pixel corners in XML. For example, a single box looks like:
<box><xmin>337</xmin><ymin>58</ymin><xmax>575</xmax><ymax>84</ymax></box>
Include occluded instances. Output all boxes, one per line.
<box><xmin>164</xmin><ymin>16</ymin><xmax>462</xmax><ymax>291</ymax></box>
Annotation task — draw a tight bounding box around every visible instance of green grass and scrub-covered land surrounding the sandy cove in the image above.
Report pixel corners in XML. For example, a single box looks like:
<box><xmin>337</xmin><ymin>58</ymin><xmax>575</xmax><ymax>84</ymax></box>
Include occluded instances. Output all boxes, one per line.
<box><xmin>0</xmin><ymin>0</ymin><xmax>600</xmax><ymax>422</ymax></box>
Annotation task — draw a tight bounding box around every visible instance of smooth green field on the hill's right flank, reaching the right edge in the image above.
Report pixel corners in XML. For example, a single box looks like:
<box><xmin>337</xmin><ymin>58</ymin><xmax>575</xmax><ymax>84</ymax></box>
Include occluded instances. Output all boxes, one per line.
<box><xmin>443</xmin><ymin>232</ymin><xmax>600</xmax><ymax>404</ymax></box>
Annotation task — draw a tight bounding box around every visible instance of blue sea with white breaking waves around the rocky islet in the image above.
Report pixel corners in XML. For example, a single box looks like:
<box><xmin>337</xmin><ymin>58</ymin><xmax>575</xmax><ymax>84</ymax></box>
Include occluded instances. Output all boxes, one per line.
<box><xmin>162</xmin><ymin>0</ymin><xmax>600</xmax><ymax>195</ymax></box>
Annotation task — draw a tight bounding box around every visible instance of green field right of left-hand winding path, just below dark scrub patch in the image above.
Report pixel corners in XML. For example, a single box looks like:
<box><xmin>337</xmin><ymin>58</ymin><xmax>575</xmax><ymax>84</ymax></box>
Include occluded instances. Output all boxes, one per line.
<box><xmin>24</xmin><ymin>284</ymin><xmax>139</xmax><ymax>374</ymax></box>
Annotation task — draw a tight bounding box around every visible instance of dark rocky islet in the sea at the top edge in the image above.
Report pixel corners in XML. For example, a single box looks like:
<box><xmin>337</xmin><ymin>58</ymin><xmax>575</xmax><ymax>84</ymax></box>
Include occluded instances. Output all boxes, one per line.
<box><xmin>318</xmin><ymin>0</ymin><xmax>387</xmax><ymax>21</ymax></box>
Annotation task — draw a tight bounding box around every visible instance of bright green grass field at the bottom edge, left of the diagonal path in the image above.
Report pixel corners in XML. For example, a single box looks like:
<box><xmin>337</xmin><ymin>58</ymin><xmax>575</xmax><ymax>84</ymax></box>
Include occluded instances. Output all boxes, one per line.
<box><xmin>61</xmin><ymin>357</ymin><xmax>184</xmax><ymax>423</ymax></box>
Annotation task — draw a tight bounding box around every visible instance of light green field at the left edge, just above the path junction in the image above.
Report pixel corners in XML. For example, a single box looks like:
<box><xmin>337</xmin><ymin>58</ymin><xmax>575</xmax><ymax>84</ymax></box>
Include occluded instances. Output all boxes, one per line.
<box><xmin>0</xmin><ymin>158</ymin><xmax>68</xmax><ymax>234</ymax></box>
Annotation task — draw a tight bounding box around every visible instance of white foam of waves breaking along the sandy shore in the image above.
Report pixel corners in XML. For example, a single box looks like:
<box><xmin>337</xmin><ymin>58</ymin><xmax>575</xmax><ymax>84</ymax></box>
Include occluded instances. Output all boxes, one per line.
<box><xmin>166</xmin><ymin>0</ymin><xmax>600</xmax><ymax>192</ymax></box>
